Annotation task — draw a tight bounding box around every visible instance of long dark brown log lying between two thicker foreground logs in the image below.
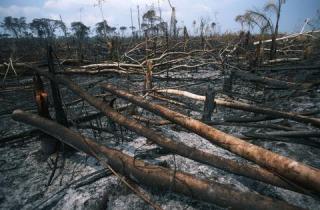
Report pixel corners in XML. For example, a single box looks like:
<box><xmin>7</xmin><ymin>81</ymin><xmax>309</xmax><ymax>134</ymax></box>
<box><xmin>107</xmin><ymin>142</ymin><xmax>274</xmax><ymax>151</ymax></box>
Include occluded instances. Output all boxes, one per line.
<box><xmin>30</xmin><ymin>70</ymin><xmax>304</xmax><ymax>192</ymax></box>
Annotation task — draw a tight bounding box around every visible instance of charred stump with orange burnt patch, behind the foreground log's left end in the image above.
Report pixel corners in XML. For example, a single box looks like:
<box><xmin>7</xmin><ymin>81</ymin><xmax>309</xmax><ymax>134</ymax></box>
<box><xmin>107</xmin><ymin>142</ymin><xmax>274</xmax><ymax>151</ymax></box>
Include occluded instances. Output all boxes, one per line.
<box><xmin>33</xmin><ymin>73</ymin><xmax>58</xmax><ymax>155</ymax></box>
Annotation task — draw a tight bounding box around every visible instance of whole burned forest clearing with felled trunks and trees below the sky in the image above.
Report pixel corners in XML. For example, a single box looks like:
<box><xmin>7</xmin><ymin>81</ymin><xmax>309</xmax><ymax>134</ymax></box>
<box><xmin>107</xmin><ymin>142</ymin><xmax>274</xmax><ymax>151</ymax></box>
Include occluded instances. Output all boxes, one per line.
<box><xmin>0</xmin><ymin>1</ymin><xmax>320</xmax><ymax>209</ymax></box>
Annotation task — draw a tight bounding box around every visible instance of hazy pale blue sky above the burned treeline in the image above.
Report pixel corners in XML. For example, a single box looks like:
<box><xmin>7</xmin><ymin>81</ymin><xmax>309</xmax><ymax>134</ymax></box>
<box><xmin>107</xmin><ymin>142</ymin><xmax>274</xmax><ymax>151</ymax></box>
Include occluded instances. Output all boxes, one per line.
<box><xmin>0</xmin><ymin>0</ymin><xmax>320</xmax><ymax>32</ymax></box>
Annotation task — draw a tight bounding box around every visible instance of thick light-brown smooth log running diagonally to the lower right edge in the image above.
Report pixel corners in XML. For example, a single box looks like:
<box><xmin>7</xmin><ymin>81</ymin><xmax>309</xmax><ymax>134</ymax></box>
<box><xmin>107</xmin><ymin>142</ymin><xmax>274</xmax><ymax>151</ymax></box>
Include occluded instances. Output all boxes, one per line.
<box><xmin>102</xmin><ymin>84</ymin><xmax>320</xmax><ymax>193</ymax></box>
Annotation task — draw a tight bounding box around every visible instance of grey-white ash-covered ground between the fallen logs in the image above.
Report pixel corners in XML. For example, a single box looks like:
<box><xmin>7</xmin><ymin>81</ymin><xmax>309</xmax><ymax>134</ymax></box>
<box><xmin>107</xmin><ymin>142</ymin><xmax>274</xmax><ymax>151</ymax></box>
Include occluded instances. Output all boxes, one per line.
<box><xmin>0</xmin><ymin>67</ymin><xmax>320</xmax><ymax>210</ymax></box>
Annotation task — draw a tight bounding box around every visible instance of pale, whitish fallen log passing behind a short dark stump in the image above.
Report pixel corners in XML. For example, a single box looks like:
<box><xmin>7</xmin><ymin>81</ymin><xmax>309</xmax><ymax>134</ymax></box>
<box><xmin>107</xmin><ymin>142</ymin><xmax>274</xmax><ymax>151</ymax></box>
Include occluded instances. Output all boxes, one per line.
<box><xmin>157</xmin><ymin>89</ymin><xmax>320</xmax><ymax>128</ymax></box>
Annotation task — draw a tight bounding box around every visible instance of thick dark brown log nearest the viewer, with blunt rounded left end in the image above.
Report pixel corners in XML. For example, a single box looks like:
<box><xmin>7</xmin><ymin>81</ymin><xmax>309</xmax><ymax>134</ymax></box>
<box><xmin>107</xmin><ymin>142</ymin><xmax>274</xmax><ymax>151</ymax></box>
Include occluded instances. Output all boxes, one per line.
<box><xmin>12</xmin><ymin>110</ymin><xmax>301</xmax><ymax>210</ymax></box>
